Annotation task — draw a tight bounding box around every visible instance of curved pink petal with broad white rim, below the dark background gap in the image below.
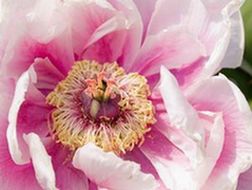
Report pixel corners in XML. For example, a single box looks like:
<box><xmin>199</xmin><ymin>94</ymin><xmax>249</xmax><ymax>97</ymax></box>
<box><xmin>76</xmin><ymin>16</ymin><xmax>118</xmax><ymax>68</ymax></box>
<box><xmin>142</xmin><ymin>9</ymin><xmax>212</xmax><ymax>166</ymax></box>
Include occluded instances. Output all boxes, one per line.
<box><xmin>189</xmin><ymin>76</ymin><xmax>252</xmax><ymax>189</ymax></box>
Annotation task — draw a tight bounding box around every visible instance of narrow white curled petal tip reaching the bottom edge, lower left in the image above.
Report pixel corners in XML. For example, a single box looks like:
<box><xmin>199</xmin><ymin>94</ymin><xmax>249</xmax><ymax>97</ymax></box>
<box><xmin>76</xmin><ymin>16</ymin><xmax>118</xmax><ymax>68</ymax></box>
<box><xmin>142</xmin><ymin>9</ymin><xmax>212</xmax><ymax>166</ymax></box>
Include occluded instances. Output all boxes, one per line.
<box><xmin>24</xmin><ymin>133</ymin><xmax>56</xmax><ymax>190</ymax></box>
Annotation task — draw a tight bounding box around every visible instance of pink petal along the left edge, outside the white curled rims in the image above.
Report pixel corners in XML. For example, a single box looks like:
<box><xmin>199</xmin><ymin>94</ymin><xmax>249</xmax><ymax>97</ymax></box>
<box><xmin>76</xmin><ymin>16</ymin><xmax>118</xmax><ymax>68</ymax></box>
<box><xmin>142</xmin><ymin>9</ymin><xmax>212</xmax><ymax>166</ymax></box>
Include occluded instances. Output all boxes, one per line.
<box><xmin>0</xmin><ymin>79</ymin><xmax>41</xmax><ymax>190</ymax></box>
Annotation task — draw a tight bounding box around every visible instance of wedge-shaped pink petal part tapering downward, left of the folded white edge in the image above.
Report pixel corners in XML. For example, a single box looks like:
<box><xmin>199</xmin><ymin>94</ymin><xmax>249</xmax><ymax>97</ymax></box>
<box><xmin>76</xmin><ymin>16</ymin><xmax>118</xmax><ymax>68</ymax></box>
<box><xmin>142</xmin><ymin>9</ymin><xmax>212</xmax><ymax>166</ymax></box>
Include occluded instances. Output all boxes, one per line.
<box><xmin>65</xmin><ymin>0</ymin><xmax>116</xmax><ymax>57</ymax></box>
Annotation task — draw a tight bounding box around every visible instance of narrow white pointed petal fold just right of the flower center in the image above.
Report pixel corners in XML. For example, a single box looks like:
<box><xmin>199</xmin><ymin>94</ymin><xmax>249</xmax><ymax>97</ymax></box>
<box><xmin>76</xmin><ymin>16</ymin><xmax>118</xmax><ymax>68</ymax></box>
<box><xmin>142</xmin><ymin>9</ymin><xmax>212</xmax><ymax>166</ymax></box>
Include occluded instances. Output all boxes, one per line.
<box><xmin>159</xmin><ymin>66</ymin><xmax>204</xmax><ymax>142</ymax></box>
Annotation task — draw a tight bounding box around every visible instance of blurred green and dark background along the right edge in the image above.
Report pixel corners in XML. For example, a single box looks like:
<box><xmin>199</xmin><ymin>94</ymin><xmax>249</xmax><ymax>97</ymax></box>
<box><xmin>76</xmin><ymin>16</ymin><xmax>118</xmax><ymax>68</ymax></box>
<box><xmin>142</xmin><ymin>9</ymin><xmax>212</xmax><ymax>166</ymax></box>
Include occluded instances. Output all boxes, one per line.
<box><xmin>222</xmin><ymin>0</ymin><xmax>252</xmax><ymax>108</ymax></box>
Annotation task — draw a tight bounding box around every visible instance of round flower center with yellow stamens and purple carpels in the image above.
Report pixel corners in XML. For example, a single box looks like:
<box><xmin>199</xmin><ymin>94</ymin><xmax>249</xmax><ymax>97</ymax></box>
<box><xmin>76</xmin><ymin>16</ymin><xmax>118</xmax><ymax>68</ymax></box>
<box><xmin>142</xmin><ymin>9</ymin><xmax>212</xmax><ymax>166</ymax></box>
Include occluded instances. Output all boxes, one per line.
<box><xmin>46</xmin><ymin>61</ymin><xmax>155</xmax><ymax>154</ymax></box>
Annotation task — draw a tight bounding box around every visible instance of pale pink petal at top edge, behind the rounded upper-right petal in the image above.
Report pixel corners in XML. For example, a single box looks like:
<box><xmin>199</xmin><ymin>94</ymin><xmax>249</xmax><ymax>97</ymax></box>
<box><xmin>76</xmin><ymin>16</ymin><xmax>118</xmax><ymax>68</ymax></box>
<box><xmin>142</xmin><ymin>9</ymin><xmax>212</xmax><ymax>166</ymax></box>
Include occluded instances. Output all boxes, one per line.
<box><xmin>148</xmin><ymin>0</ymin><xmax>206</xmax><ymax>35</ymax></box>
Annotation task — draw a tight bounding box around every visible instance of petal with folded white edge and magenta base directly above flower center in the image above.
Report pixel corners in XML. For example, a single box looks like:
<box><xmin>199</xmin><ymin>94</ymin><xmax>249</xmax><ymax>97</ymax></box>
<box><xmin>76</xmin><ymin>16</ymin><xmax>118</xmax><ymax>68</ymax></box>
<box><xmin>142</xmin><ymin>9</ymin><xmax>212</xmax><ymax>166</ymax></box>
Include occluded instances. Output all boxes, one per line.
<box><xmin>67</xmin><ymin>0</ymin><xmax>142</xmax><ymax>66</ymax></box>
